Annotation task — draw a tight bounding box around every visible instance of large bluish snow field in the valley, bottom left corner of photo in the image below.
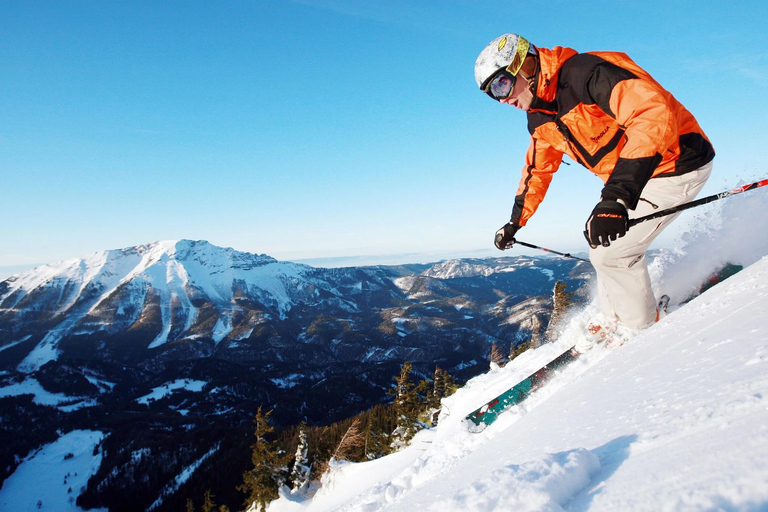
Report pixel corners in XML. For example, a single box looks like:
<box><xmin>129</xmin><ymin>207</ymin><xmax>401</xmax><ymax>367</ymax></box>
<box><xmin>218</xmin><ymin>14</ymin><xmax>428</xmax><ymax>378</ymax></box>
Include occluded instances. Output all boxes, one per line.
<box><xmin>0</xmin><ymin>430</ymin><xmax>106</xmax><ymax>512</ymax></box>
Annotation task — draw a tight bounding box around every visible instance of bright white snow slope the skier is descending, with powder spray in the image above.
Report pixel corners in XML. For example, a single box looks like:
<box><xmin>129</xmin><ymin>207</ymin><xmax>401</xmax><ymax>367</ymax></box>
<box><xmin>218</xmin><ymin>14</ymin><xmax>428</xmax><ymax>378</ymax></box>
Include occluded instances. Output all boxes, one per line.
<box><xmin>268</xmin><ymin>189</ymin><xmax>768</xmax><ymax>512</ymax></box>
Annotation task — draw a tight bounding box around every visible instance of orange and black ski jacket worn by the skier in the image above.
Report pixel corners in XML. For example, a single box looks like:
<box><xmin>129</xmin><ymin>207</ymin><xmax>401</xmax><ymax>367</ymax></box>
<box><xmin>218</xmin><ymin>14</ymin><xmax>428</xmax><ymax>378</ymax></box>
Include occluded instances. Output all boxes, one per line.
<box><xmin>511</xmin><ymin>46</ymin><xmax>715</xmax><ymax>226</ymax></box>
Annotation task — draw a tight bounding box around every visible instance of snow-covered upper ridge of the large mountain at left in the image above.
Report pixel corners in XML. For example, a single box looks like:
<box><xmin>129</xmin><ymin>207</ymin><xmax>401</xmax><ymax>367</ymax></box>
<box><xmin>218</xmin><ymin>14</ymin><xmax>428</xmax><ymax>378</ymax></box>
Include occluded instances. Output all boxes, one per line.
<box><xmin>0</xmin><ymin>240</ymin><xmax>326</xmax><ymax>372</ymax></box>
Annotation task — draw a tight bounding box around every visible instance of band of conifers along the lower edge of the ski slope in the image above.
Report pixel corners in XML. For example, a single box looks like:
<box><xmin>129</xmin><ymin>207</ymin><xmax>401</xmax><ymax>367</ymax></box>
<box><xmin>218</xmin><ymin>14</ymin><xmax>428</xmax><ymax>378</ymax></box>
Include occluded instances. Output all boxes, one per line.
<box><xmin>187</xmin><ymin>362</ymin><xmax>457</xmax><ymax>512</ymax></box>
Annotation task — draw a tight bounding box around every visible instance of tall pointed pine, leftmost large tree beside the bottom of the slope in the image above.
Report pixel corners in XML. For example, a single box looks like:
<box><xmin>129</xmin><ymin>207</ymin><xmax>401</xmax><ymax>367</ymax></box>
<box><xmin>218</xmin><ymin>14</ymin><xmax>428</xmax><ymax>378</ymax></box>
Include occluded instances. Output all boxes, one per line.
<box><xmin>237</xmin><ymin>407</ymin><xmax>288</xmax><ymax>511</ymax></box>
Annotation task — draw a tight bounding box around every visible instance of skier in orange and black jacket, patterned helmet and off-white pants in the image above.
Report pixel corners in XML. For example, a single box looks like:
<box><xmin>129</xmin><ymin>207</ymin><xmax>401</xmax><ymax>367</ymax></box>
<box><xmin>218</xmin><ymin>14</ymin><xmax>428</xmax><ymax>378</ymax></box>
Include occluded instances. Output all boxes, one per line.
<box><xmin>475</xmin><ymin>34</ymin><xmax>715</xmax><ymax>351</ymax></box>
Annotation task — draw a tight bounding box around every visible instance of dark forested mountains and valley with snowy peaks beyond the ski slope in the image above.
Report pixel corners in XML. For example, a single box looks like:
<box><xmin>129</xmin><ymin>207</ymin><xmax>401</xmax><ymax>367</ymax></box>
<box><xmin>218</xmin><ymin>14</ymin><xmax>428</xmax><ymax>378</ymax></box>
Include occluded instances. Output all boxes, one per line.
<box><xmin>0</xmin><ymin>240</ymin><xmax>591</xmax><ymax>510</ymax></box>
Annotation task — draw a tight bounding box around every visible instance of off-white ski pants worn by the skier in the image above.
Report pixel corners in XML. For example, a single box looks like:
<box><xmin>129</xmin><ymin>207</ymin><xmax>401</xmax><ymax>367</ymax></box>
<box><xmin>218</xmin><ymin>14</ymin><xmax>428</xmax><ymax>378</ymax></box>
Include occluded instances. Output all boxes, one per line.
<box><xmin>589</xmin><ymin>162</ymin><xmax>712</xmax><ymax>329</ymax></box>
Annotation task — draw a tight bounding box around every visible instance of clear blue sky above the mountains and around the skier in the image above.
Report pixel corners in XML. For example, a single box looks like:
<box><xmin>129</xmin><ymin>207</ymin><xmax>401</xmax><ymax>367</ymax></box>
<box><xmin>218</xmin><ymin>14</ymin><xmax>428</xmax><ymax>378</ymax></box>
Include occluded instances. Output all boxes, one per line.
<box><xmin>0</xmin><ymin>0</ymin><xmax>768</xmax><ymax>276</ymax></box>
